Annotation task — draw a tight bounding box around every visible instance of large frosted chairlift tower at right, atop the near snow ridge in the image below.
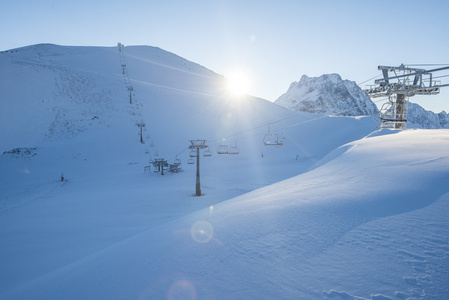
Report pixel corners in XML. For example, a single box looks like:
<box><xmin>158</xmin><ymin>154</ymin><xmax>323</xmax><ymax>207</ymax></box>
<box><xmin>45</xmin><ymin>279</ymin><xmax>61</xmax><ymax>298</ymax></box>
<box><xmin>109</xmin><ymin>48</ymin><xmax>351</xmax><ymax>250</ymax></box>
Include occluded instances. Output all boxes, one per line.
<box><xmin>365</xmin><ymin>64</ymin><xmax>449</xmax><ymax>129</ymax></box>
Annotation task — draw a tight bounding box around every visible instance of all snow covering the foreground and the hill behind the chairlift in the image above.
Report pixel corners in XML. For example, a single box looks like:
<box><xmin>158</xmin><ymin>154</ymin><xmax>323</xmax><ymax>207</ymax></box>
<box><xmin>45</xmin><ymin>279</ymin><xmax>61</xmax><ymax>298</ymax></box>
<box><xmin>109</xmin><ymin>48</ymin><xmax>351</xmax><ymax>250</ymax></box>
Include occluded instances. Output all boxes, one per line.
<box><xmin>0</xmin><ymin>45</ymin><xmax>449</xmax><ymax>299</ymax></box>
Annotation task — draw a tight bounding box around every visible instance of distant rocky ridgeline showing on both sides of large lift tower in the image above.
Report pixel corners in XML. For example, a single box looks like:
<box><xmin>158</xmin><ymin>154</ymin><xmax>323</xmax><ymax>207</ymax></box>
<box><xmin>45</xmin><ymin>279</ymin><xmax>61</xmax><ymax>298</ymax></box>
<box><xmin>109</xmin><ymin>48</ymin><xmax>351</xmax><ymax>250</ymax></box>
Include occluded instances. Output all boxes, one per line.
<box><xmin>275</xmin><ymin>74</ymin><xmax>449</xmax><ymax>128</ymax></box>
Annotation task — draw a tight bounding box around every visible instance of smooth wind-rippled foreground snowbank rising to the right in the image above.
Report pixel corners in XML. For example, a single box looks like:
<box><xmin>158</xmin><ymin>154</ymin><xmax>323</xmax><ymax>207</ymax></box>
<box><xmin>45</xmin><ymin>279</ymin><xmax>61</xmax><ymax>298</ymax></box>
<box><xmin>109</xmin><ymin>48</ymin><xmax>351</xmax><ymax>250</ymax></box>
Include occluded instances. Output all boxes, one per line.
<box><xmin>4</xmin><ymin>131</ymin><xmax>449</xmax><ymax>299</ymax></box>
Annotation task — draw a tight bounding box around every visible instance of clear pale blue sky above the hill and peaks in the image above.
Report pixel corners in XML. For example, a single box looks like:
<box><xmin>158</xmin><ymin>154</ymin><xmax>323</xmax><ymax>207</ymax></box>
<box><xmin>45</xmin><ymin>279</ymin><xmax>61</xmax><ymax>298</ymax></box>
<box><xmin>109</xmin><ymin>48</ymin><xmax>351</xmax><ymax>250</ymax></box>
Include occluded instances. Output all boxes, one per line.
<box><xmin>0</xmin><ymin>0</ymin><xmax>449</xmax><ymax>112</ymax></box>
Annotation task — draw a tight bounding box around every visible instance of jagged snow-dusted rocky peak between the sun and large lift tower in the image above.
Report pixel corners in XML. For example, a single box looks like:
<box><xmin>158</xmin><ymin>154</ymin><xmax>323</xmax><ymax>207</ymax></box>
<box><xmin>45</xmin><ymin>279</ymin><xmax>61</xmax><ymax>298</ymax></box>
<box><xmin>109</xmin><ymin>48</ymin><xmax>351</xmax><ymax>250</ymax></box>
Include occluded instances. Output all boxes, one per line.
<box><xmin>275</xmin><ymin>74</ymin><xmax>379</xmax><ymax>116</ymax></box>
